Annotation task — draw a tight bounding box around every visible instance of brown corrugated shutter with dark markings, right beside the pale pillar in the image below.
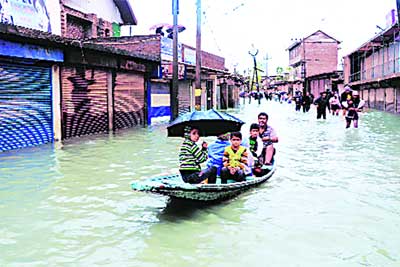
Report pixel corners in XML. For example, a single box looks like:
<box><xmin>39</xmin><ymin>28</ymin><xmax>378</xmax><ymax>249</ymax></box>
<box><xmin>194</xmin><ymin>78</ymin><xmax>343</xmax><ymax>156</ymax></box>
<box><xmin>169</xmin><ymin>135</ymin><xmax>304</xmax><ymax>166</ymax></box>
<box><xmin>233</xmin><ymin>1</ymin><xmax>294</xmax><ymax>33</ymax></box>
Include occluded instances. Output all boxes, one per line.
<box><xmin>61</xmin><ymin>67</ymin><xmax>108</xmax><ymax>139</ymax></box>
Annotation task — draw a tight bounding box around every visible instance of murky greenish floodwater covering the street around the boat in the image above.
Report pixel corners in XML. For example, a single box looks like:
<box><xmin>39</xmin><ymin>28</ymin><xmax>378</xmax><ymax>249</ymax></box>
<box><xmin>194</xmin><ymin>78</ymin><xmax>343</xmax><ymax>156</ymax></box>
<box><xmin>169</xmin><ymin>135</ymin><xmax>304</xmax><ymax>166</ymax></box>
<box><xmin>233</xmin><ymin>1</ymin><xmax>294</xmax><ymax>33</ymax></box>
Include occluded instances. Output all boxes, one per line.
<box><xmin>0</xmin><ymin>101</ymin><xmax>400</xmax><ymax>267</ymax></box>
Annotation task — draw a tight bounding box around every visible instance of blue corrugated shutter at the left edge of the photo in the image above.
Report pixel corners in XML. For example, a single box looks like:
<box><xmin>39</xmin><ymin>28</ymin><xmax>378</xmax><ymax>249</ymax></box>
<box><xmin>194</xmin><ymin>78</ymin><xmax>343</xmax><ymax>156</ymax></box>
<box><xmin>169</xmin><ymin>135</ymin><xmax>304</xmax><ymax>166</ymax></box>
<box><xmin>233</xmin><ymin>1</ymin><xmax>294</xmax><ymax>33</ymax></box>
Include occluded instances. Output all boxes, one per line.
<box><xmin>0</xmin><ymin>63</ymin><xmax>53</xmax><ymax>151</ymax></box>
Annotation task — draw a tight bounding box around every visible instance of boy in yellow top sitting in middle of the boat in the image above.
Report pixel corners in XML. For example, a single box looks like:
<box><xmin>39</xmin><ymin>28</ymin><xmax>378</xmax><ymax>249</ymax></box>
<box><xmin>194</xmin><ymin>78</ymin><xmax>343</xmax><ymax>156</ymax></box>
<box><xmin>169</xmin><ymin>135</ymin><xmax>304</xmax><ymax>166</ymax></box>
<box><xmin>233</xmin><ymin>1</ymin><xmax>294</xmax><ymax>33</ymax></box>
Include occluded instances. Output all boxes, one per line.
<box><xmin>221</xmin><ymin>132</ymin><xmax>248</xmax><ymax>184</ymax></box>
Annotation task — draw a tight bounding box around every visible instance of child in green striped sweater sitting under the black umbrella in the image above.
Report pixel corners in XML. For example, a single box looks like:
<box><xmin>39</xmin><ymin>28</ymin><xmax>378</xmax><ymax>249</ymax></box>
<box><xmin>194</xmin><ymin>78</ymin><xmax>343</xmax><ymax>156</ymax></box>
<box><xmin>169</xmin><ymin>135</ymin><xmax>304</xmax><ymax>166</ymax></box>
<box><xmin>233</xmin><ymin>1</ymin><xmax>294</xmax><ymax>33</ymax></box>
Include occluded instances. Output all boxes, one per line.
<box><xmin>179</xmin><ymin>126</ymin><xmax>217</xmax><ymax>184</ymax></box>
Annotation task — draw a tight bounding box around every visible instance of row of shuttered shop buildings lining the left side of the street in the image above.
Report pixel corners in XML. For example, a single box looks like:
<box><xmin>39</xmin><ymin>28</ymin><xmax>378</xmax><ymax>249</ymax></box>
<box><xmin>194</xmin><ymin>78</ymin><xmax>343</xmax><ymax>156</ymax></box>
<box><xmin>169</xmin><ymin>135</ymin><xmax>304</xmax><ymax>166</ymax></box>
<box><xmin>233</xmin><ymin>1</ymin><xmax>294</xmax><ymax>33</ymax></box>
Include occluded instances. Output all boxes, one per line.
<box><xmin>0</xmin><ymin>0</ymin><xmax>235</xmax><ymax>151</ymax></box>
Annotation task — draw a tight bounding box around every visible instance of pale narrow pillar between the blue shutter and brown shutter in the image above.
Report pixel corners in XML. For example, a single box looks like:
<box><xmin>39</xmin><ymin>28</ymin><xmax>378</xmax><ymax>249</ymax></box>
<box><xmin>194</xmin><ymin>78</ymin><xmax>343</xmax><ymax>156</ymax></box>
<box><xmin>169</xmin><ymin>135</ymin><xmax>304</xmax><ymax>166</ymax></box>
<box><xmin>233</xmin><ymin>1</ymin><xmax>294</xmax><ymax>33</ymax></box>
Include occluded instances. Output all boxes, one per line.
<box><xmin>51</xmin><ymin>65</ymin><xmax>62</xmax><ymax>142</ymax></box>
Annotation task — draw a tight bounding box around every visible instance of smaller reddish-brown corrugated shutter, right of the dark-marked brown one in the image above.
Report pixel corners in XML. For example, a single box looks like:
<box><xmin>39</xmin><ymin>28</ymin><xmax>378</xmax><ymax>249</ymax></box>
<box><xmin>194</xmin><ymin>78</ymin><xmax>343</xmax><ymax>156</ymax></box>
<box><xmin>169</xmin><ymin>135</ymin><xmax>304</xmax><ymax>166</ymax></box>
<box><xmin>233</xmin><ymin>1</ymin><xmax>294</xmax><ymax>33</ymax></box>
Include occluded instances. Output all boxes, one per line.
<box><xmin>114</xmin><ymin>72</ymin><xmax>144</xmax><ymax>129</ymax></box>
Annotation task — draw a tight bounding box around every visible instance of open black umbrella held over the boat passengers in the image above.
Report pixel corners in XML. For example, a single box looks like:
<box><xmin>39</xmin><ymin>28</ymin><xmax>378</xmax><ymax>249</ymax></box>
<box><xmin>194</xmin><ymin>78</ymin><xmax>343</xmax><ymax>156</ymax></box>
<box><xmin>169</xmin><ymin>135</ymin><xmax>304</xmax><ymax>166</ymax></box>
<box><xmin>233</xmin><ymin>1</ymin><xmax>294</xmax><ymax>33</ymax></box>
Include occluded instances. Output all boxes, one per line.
<box><xmin>167</xmin><ymin>109</ymin><xmax>244</xmax><ymax>137</ymax></box>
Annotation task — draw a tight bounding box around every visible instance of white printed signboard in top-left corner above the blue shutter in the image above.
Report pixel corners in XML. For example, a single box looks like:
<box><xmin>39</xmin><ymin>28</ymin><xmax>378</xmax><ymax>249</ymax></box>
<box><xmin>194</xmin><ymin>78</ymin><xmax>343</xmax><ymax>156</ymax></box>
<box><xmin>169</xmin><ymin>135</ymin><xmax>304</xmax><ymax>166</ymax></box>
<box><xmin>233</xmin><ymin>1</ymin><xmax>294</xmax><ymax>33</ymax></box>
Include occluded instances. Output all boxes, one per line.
<box><xmin>0</xmin><ymin>0</ymin><xmax>51</xmax><ymax>32</ymax></box>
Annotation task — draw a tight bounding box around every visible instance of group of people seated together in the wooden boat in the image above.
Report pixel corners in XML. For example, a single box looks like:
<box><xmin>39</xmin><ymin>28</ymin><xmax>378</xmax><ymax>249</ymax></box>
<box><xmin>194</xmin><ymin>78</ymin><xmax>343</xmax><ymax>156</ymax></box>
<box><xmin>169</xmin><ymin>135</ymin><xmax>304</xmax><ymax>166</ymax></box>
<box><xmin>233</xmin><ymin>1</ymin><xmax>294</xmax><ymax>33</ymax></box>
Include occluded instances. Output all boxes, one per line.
<box><xmin>179</xmin><ymin>112</ymin><xmax>279</xmax><ymax>184</ymax></box>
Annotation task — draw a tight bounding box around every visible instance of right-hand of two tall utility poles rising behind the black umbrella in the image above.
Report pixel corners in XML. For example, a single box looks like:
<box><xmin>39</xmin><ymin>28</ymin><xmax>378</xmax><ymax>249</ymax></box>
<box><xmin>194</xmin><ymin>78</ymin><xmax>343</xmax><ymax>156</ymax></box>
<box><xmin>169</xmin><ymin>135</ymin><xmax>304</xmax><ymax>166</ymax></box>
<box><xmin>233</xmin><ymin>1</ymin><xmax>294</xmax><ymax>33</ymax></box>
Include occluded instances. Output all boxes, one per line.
<box><xmin>195</xmin><ymin>0</ymin><xmax>204</xmax><ymax>110</ymax></box>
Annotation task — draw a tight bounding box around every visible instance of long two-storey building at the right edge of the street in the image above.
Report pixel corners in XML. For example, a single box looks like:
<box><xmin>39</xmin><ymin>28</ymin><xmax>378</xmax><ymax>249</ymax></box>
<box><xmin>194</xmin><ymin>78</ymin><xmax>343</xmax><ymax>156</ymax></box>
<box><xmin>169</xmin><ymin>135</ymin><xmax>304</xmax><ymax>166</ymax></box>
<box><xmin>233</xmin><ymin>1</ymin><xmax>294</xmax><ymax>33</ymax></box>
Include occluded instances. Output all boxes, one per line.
<box><xmin>344</xmin><ymin>24</ymin><xmax>400</xmax><ymax>114</ymax></box>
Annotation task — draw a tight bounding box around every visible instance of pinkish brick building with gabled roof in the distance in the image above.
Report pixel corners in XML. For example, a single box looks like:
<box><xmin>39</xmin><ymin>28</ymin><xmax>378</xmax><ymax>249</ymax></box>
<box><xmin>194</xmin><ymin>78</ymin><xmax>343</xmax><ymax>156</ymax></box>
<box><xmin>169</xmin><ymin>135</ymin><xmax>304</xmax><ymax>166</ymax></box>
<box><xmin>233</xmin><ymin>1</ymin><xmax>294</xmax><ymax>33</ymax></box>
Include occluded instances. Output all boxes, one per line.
<box><xmin>287</xmin><ymin>30</ymin><xmax>340</xmax><ymax>95</ymax></box>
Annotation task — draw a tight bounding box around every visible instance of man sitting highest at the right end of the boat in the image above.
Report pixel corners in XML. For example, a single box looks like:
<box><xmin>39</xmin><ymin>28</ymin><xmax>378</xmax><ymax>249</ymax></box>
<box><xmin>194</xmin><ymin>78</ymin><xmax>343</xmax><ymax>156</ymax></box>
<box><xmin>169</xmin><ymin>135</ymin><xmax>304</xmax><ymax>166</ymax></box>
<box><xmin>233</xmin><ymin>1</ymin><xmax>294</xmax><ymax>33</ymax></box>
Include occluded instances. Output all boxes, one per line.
<box><xmin>258</xmin><ymin>112</ymin><xmax>279</xmax><ymax>169</ymax></box>
